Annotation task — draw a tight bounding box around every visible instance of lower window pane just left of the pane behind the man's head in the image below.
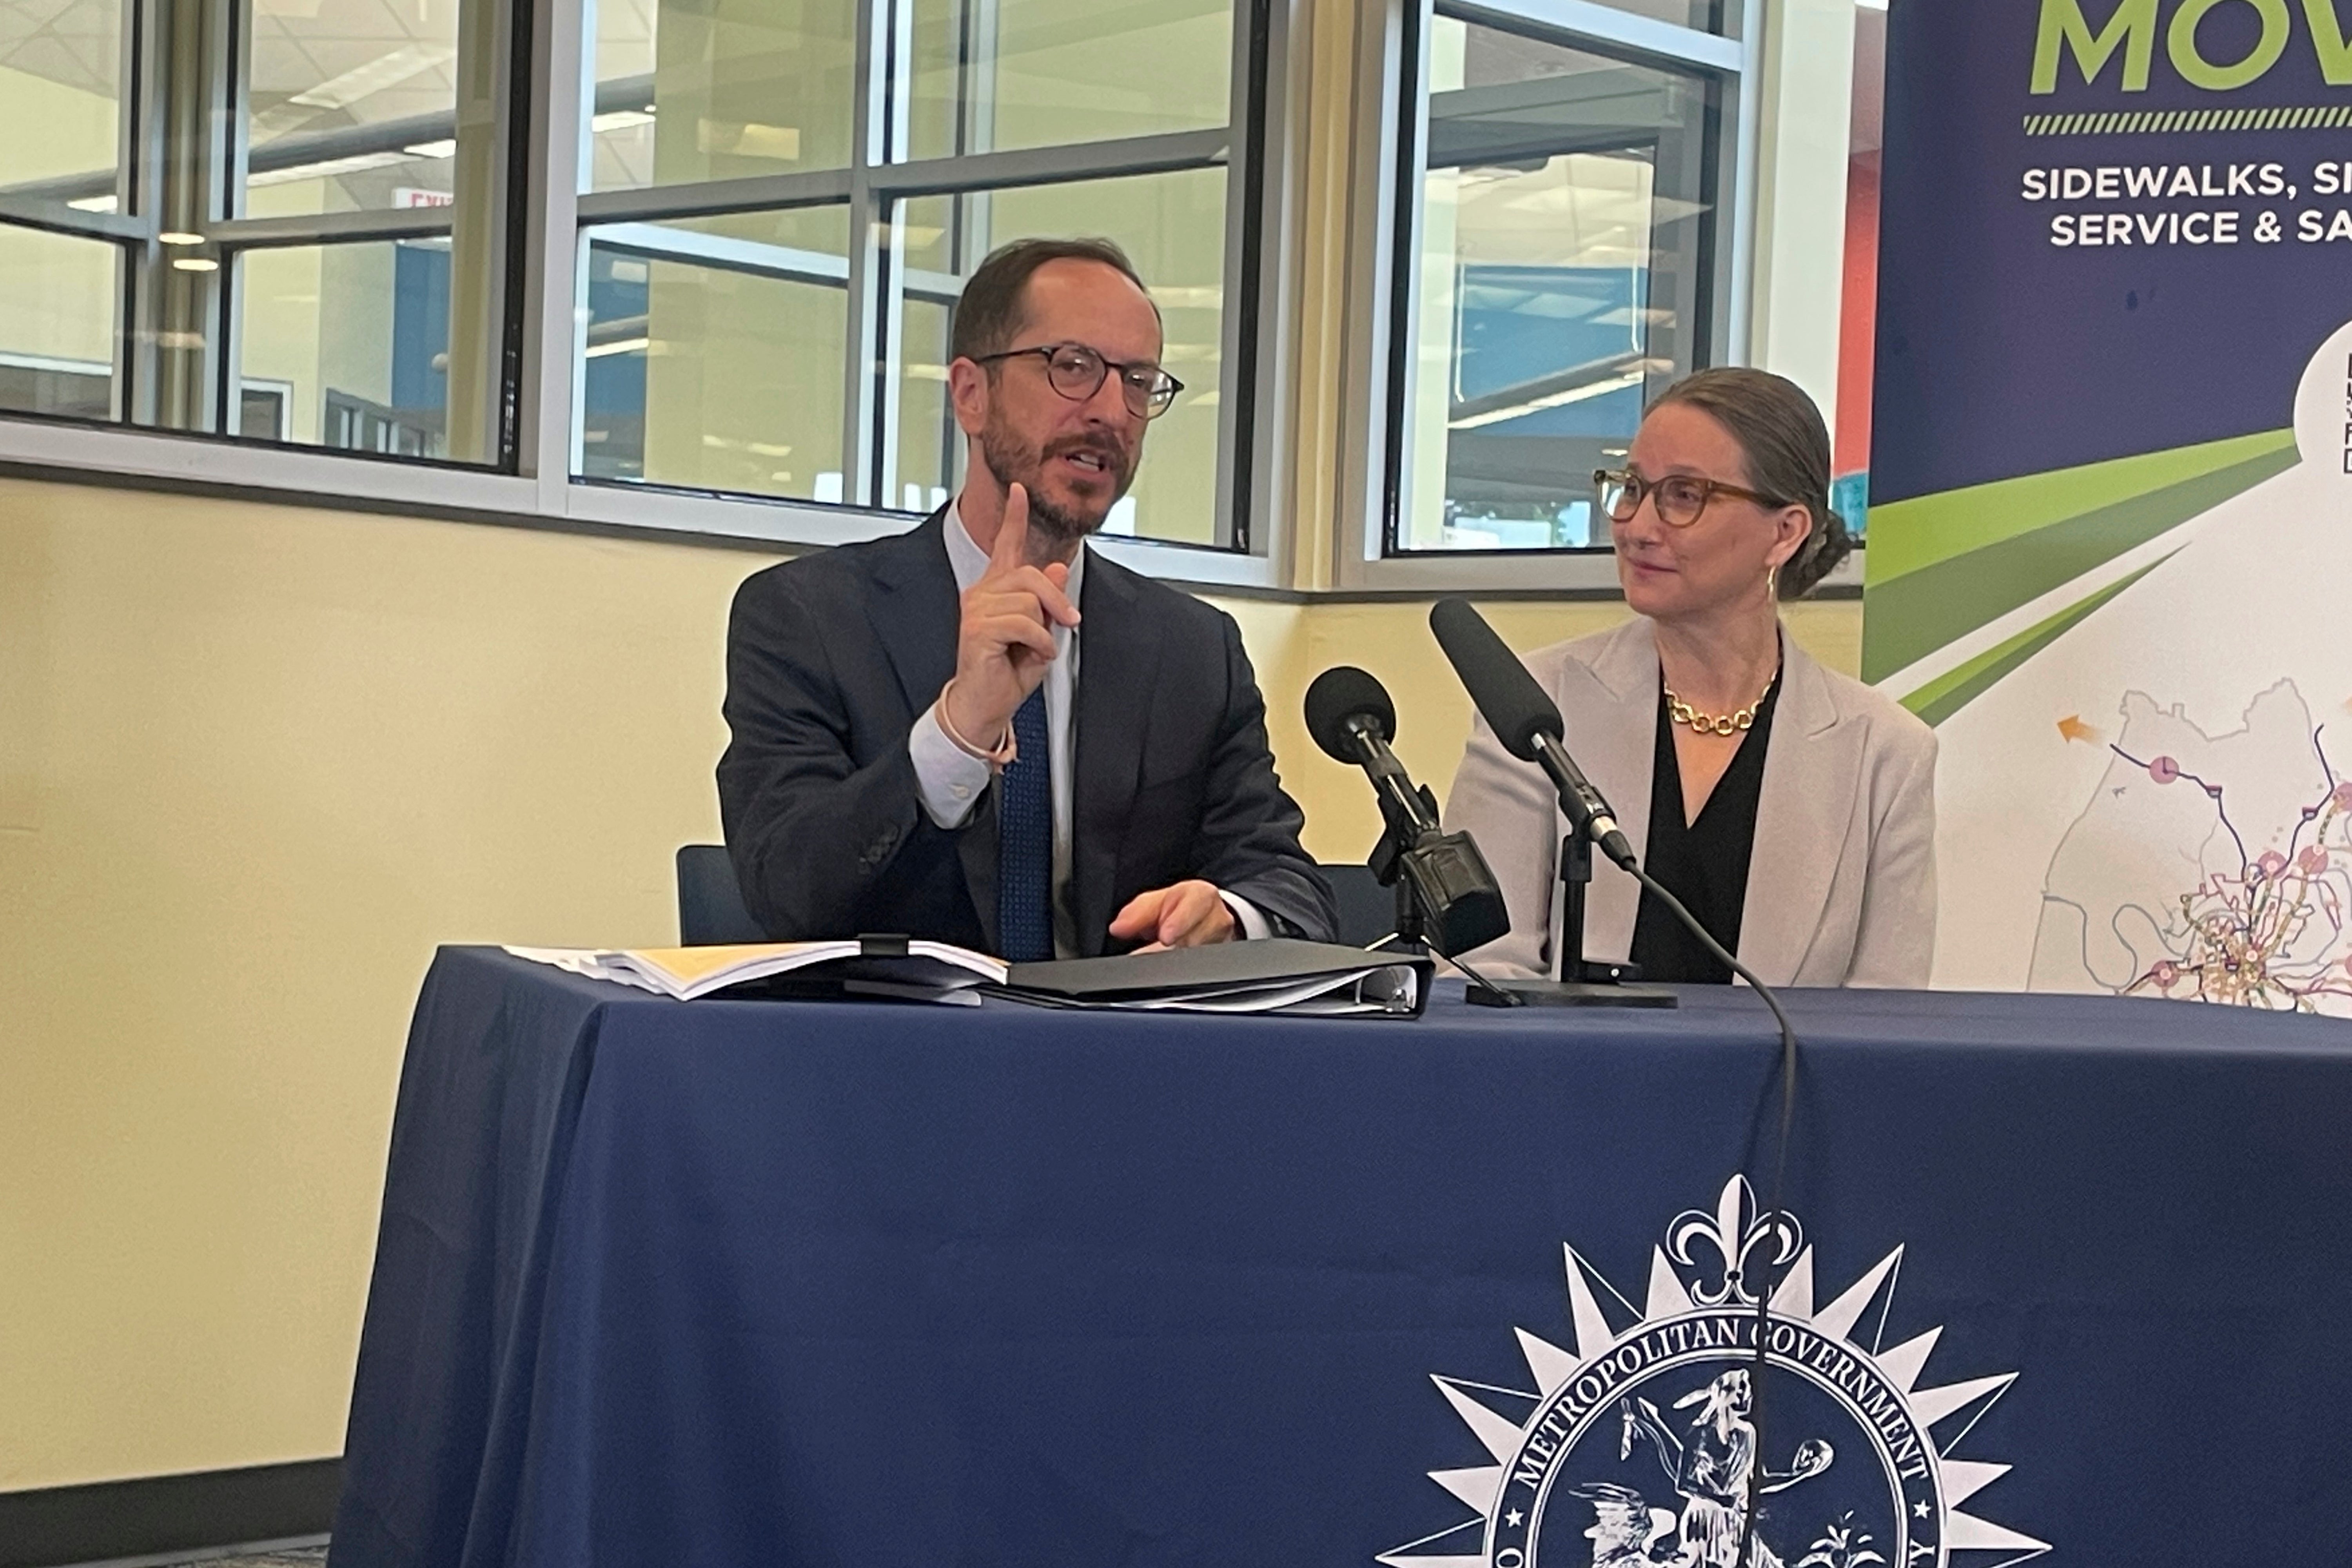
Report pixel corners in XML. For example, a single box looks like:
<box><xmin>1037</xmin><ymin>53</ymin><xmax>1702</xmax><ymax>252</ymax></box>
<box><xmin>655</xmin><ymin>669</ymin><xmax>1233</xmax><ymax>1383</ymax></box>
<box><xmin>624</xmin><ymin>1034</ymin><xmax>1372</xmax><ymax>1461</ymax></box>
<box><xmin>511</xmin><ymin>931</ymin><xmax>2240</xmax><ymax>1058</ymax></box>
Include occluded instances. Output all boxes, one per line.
<box><xmin>581</xmin><ymin>207</ymin><xmax>849</xmax><ymax>501</ymax></box>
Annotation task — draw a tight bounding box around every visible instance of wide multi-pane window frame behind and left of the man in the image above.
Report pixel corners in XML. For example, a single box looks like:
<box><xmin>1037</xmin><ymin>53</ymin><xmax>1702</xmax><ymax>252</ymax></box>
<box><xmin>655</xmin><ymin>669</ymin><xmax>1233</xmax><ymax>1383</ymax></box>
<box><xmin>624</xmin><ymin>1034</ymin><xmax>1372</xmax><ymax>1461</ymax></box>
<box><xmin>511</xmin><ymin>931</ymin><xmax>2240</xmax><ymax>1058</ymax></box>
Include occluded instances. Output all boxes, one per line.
<box><xmin>0</xmin><ymin>0</ymin><xmax>1301</xmax><ymax>590</ymax></box>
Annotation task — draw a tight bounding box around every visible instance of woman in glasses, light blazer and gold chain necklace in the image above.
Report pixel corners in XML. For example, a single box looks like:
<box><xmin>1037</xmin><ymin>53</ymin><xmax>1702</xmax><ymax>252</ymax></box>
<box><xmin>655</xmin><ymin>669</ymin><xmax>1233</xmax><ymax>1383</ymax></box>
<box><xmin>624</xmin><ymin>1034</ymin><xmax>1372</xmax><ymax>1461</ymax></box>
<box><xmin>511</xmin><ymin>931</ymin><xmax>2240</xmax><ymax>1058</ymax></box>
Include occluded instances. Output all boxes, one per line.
<box><xmin>1446</xmin><ymin>369</ymin><xmax>1936</xmax><ymax>987</ymax></box>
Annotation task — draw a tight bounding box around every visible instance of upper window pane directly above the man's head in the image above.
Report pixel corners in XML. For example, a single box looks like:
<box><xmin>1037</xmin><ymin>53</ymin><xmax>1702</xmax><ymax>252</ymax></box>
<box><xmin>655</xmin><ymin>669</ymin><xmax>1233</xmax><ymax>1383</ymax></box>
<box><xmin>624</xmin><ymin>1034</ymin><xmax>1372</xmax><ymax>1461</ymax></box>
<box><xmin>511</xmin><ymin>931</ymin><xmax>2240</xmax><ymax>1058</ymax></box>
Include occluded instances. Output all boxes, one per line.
<box><xmin>901</xmin><ymin>0</ymin><xmax>1232</xmax><ymax>158</ymax></box>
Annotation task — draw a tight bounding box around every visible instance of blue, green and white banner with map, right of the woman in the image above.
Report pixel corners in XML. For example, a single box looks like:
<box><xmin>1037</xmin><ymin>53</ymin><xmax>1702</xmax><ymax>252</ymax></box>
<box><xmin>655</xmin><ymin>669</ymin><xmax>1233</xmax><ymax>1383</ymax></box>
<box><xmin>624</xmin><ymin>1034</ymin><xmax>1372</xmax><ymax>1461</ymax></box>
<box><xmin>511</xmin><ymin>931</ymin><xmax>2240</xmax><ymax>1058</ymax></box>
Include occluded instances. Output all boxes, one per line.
<box><xmin>1863</xmin><ymin>0</ymin><xmax>2352</xmax><ymax>1016</ymax></box>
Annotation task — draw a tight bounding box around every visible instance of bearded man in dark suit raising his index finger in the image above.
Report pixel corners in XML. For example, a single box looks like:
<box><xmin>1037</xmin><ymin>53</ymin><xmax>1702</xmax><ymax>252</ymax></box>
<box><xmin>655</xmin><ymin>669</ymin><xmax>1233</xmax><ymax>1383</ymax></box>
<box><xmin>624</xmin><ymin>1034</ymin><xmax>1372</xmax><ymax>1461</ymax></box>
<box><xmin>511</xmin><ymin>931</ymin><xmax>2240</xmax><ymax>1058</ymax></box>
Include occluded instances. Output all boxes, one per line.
<box><xmin>717</xmin><ymin>240</ymin><xmax>1334</xmax><ymax>962</ymax></box>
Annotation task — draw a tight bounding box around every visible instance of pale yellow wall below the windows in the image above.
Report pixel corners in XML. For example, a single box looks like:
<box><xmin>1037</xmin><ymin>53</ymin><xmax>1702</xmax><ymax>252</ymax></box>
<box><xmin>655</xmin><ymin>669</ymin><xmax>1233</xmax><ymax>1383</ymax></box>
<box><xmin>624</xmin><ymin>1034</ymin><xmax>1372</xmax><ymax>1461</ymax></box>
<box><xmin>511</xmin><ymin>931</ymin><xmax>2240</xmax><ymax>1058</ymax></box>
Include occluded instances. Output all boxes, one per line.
<box><xmin>0</xmin><ymin>482</ymin><xmax>1860</xmax><ymax>1490</ymax></box>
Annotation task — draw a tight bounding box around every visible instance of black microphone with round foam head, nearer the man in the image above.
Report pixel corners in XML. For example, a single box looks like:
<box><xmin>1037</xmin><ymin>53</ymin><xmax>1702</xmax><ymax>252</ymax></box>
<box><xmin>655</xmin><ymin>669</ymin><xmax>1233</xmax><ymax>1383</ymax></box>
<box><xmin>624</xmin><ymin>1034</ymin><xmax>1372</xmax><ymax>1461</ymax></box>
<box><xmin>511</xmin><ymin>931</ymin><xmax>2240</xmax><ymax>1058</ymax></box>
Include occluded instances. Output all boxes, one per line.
<box><xmin>1305</xmin><ymin>665</ymin><xmax>1510</xmax><ymax>959</ymax></box>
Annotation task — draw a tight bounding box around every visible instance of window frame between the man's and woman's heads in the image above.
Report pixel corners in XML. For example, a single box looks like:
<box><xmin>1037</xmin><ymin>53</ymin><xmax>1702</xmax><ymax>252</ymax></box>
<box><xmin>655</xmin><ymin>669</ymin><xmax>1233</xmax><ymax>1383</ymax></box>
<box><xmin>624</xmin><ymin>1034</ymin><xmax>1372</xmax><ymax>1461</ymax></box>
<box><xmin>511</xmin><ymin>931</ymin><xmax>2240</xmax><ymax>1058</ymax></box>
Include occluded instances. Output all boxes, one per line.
<box><xmin>1331</xmin><ymin>0</ymin><xmax>1766</xmax><ymax>599</ymax></box>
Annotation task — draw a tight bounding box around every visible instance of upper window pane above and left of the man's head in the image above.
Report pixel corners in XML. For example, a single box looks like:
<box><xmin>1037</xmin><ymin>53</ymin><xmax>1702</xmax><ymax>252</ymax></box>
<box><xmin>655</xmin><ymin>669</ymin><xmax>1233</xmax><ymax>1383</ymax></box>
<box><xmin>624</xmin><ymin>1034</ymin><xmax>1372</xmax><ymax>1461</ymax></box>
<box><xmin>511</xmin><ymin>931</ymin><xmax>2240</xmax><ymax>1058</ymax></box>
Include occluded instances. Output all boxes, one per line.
<box><xmin>588</xmin><ymin>0</ymin><xmax>856</xmax><ymax>191</ymax></box>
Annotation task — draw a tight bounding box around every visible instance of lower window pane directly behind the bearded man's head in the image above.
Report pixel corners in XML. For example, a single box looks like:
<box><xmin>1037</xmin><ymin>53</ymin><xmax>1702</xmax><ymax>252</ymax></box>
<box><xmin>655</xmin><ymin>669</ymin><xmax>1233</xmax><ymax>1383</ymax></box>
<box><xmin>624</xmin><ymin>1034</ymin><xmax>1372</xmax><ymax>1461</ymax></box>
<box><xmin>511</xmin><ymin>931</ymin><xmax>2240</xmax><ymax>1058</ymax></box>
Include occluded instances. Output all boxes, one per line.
<box><xmin>894</xmin><ymin>169</ymin><xmax>1225</xmax><ymax>545</ymax></box>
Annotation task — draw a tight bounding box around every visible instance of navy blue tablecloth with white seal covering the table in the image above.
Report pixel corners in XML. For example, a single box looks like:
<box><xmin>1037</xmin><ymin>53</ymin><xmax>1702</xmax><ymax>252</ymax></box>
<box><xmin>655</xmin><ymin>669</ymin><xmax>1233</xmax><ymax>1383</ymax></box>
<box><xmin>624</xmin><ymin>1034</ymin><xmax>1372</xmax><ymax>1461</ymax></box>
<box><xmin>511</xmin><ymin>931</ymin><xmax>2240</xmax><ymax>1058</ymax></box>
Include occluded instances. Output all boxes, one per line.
<box><xmin>332</xmin><ymin>950</ymin><xmax>2352</xmax><ymax>1568</ymax></box>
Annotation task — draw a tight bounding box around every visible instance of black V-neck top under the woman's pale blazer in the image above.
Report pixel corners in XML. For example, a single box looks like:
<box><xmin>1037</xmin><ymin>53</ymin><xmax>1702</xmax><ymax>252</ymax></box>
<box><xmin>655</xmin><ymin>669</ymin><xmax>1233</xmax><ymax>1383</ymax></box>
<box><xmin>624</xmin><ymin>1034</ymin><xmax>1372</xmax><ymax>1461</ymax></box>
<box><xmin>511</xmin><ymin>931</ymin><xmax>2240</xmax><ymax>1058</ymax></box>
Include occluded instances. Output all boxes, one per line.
<box><xmin>1632</xmin><ymin>677</ymin><xmax>1780</xmax><ymax>985</ymax></box>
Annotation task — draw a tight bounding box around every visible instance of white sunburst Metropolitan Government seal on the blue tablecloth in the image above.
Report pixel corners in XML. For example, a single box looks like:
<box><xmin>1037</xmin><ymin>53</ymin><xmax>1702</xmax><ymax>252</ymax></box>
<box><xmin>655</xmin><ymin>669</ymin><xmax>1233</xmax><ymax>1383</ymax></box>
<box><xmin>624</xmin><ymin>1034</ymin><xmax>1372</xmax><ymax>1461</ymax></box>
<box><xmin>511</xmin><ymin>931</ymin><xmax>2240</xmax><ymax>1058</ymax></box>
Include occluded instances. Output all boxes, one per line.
<box><xmin>1378</xmin><ymin>1176</ymin><xmax>2051</xmax><ymax>1568</ymax></box>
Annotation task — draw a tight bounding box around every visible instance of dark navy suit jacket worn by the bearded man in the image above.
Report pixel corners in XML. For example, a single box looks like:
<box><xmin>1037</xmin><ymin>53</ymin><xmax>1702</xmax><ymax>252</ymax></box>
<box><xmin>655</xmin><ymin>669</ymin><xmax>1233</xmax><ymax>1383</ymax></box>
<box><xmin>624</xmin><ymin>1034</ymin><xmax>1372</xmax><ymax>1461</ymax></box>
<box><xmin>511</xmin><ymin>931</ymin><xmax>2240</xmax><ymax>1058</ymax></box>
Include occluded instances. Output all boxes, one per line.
<box><xmin>717</xmin><ymin>512</ymin><xmax>1336</xmax><ymax>957</ymax></box>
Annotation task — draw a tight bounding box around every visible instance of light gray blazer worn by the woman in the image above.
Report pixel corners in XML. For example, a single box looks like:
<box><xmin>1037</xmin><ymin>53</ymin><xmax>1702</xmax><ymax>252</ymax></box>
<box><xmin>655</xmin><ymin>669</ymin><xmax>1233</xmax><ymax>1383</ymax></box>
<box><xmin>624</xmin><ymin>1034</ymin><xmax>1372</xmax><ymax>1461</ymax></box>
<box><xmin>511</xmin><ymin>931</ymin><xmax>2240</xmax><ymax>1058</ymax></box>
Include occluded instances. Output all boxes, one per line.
<box><xmin>1446</xmin><ymin>618</ymin><xmax>1936</xmax><ymax>987</ymax></box>
